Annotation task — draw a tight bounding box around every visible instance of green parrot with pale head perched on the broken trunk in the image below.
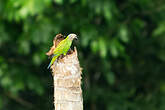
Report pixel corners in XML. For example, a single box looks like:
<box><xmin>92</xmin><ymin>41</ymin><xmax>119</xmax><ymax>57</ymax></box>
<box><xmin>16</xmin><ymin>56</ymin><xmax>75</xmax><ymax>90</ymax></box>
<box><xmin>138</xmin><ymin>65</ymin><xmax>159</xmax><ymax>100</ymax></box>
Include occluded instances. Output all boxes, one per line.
<box><xmin>48</xmin><ymin>34</ymin><xmax>77</xmax><ymax>69</ymax></box>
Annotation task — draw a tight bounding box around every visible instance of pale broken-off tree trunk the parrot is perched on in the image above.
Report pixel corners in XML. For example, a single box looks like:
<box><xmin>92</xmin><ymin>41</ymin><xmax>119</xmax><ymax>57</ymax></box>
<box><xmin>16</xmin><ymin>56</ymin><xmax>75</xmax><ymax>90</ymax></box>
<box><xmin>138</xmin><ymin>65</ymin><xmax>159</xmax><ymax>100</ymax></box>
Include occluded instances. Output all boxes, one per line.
<box><xmin>46</xmin><ymin>34</ymin><xmax>83</xmax><ymax>110</ymax></box>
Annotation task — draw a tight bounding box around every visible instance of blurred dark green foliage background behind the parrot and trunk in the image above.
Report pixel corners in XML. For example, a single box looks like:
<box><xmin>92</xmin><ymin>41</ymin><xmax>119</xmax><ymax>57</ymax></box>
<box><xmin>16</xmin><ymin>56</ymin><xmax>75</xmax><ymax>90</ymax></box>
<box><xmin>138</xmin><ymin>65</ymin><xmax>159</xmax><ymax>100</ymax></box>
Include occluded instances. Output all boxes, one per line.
<box><xmin>0</xmin><ymin>0</ymin><xmax>165</xmax><ymax>110</ymax></box>
